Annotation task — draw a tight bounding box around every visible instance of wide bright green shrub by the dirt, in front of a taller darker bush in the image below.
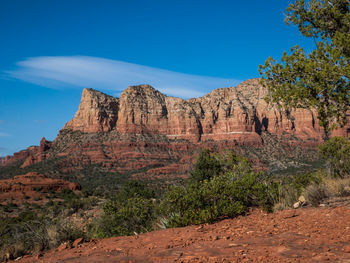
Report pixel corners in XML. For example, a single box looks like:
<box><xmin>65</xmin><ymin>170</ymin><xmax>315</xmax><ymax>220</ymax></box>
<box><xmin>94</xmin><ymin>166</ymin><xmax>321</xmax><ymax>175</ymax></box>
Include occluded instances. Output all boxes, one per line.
<box><xmin>162</xmin><ymin>172</ymin><xmax>272</xmax><ymax>227</ymax></box>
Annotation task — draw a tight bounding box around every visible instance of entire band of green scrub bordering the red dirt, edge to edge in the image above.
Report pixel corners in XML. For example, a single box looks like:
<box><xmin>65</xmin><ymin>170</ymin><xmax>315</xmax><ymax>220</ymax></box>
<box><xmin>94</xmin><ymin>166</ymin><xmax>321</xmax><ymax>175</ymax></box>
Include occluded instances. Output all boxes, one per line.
<box><xmin>0</xmin><ymin>138</ymin><xmax>350</xmax><ymax>259</ymax></box>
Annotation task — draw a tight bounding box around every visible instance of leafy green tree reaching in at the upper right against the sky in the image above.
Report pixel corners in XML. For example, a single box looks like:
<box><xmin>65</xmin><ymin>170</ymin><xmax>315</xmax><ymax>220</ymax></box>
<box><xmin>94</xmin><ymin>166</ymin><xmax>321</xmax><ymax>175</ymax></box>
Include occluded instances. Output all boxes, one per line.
<box><xmin>259</xmin><ymin>0</ymin><xmax>350</xmax><ymax>140</ymax></box>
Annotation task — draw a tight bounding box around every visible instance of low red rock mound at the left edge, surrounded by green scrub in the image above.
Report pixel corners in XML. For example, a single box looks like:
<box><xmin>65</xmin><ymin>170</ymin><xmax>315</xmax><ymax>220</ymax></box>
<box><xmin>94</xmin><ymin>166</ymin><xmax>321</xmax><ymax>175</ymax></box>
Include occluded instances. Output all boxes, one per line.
<box><xmin>0</xmin><ymin>172</ymin><xmax>81</xmax><ymax>203</ymax></box>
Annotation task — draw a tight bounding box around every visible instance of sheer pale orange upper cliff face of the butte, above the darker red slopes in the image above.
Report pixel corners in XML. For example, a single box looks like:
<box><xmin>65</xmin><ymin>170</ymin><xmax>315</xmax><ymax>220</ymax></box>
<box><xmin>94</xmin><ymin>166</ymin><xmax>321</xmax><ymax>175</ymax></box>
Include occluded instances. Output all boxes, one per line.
<box><xmin>64</xmin><ymin>79</ymin><xmax>348</xmax><ymax>145</ymax></box>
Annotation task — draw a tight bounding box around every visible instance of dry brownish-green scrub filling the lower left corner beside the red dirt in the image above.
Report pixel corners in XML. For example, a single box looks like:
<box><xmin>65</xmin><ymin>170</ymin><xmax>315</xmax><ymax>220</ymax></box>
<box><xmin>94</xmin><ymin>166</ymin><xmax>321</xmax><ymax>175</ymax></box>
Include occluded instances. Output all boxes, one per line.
<box><xmin>0</xmin><ymin>190</ymin><xmax>99</xmax><ymax>260</ymax></box>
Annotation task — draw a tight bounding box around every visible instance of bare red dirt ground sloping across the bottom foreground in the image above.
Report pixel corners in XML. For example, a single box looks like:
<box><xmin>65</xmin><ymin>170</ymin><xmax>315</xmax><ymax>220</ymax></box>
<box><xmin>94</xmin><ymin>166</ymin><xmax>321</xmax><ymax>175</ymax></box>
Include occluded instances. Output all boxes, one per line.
<box><xmin>18</xmin><ymin>206</ymin><xmax>350</xmax><ymax>262</ymax></box>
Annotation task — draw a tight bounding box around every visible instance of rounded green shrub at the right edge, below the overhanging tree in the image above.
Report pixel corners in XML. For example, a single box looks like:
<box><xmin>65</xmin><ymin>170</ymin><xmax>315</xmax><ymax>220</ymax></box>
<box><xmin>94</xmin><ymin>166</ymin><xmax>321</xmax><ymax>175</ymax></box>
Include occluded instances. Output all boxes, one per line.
<box><xmin>319</xmin><ymin>137</ymin><xmax>350</xmax><ymax>178</ymax></box>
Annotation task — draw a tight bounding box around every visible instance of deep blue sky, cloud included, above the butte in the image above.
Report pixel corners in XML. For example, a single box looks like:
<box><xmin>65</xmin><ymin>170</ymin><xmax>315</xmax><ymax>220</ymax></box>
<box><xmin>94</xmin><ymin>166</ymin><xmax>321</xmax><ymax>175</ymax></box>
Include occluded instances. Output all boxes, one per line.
<box><xmin>0</xmin><ymin>0</ymin><xmax>313</xmax><ymax>156</ymax></box>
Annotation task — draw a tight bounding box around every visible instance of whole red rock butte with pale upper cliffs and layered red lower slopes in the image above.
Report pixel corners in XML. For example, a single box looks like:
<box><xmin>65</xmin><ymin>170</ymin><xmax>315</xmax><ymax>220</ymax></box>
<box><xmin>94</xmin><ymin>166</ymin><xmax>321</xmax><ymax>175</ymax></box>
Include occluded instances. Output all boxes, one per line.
<box><xmin>0</xmin><ymin>79</ymin><xmax>350</xmax><ymax>178</ymax></box>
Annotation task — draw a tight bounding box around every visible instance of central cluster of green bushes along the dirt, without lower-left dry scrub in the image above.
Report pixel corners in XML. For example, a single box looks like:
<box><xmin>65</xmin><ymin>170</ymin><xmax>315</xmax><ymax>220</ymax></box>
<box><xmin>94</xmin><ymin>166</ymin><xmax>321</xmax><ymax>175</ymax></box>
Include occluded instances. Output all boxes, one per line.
<box><xmin>89</xmin><ymin>150</ymin><xmax>328</xmax><ymax>234</ymax></box>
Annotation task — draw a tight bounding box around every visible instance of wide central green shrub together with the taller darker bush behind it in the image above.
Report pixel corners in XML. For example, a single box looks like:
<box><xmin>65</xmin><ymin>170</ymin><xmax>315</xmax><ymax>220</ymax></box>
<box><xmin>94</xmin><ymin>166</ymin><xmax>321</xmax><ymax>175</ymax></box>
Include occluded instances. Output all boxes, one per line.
<box><xmin>161</xmin><ymin>151</ymin><xmax>277</xmax><ymax>227</ymax></box>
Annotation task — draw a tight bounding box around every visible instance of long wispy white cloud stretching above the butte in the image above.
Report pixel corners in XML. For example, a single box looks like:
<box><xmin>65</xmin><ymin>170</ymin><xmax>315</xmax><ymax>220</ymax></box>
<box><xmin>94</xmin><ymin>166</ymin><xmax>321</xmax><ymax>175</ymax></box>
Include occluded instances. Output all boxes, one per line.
<box><xmin>6</xmin><ymin>56</ymin><xmax>239</xmax><ymax>98</ymax></box>
